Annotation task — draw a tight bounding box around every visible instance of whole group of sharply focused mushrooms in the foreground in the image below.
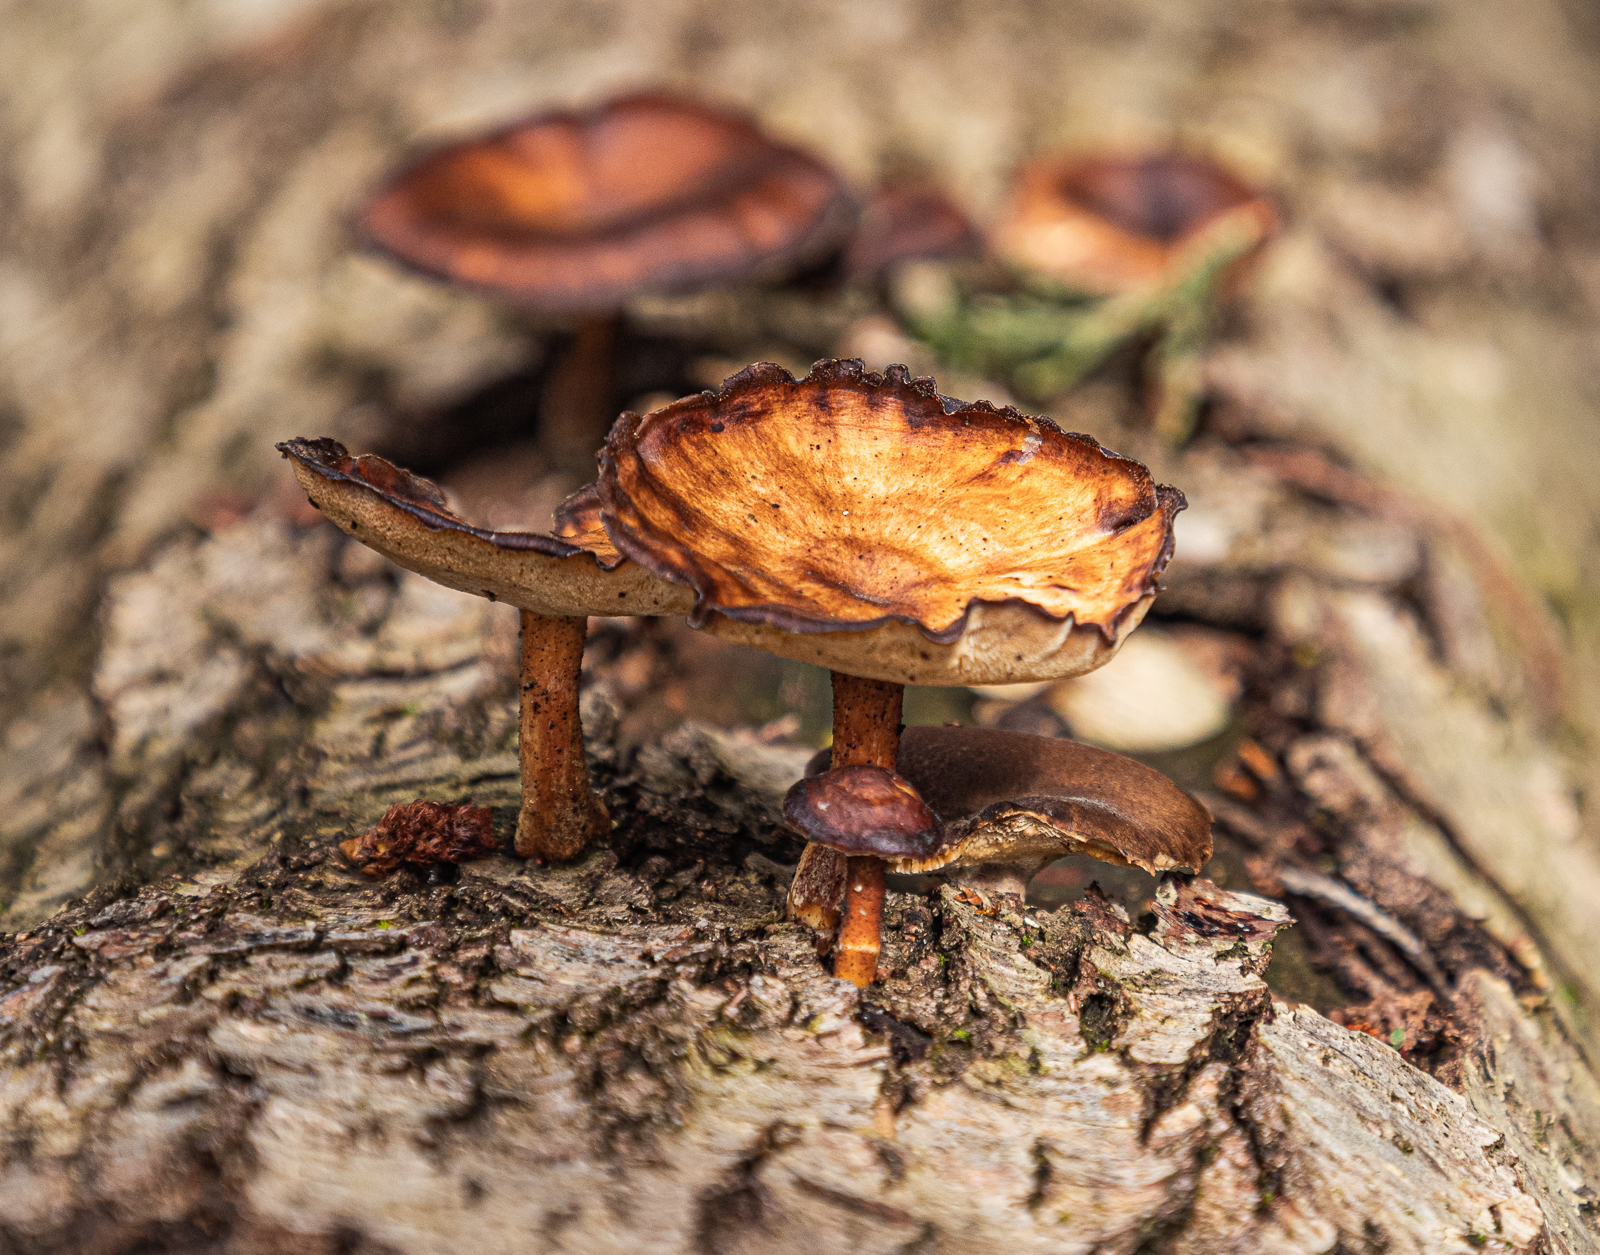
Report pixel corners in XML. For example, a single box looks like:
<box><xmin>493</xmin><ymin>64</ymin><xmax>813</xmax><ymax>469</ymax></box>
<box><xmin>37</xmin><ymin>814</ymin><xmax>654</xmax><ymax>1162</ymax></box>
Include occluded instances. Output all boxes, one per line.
<box><xmin>280</xmin><ymin>362</ymin><xmax>1211</xmax><ymax>986</ymax></box>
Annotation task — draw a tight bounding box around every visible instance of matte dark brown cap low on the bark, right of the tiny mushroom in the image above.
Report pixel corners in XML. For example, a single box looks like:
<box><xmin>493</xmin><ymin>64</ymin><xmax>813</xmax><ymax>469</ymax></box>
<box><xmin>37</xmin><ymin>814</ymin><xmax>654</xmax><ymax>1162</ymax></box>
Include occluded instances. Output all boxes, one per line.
<box><xmin>806</xmin><ymin>727</ymin><xmax>1211</xmax><ymax>876</ymax></box>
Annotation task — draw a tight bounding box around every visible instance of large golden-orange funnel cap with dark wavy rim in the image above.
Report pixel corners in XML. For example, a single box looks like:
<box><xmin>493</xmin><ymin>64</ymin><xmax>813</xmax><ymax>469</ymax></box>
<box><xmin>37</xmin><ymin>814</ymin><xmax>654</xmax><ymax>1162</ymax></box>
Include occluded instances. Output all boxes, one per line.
<box><xmin>598</xmin><ymin>360</ymin><xmax>1184</xmax><ymax>684</ymax></box>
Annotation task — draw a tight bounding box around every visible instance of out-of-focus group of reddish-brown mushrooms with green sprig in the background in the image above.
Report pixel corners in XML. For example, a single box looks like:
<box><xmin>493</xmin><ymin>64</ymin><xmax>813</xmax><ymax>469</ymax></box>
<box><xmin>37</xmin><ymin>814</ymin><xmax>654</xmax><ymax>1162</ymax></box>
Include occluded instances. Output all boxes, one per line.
<box><xmin>358</xmin><ymin>94</ymin><xmax>1278</xmax><ymax>464</ymax></box>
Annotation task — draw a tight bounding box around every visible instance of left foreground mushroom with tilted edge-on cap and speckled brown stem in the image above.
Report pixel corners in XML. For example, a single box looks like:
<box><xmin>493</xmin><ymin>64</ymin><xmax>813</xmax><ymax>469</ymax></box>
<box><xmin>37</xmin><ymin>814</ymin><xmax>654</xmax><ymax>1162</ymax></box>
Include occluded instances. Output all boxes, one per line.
<box><xmin>278</xmin><ymin>440</ymin><xmax>690</xmax><ymax>860</ymax></box>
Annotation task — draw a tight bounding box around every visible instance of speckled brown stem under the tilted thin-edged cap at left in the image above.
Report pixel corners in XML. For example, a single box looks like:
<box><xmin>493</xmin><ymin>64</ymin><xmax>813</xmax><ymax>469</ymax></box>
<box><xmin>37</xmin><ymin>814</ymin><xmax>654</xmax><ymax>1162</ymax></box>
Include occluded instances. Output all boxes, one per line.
<box><xmin>517</xmin><ymin>610</ymin><xmax>611</xmax><ymax>861</ymax></box>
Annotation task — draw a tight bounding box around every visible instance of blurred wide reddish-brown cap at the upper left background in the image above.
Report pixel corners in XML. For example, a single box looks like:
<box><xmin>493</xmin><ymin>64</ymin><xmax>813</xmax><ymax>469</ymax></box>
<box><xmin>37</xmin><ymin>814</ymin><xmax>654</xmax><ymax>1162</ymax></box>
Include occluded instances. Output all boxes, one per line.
<box><xmin>360</xmin><ymin>94</ymin><xmax>856</xmax><ymax>312</ymax></box>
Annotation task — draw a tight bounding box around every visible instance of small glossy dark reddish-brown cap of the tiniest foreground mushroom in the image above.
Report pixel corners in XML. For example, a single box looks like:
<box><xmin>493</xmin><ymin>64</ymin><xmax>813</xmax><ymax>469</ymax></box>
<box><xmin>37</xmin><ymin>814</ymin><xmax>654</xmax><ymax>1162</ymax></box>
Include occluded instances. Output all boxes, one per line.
<box><xmin>784</xmin><ymin>767</ymin><xmax>944</xmax><ymax>858</ymax></box>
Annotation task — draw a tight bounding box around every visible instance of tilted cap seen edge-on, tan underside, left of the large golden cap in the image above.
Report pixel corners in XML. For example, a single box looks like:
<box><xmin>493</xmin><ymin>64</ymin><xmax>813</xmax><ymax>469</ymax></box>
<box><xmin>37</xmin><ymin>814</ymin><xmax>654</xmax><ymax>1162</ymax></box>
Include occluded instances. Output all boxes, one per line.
<box><xmin>278</xmin><ymin>440</ymin><xmax>693</xmax><ymax>615</ymax></box>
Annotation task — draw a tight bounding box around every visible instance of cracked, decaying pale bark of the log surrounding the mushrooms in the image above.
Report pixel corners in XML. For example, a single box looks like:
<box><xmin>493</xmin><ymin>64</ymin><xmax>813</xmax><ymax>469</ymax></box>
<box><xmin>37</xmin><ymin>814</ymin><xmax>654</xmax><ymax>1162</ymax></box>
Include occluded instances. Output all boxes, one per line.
<box><xmin>0</xmin><ymin>0</ymin><xmax>1600</xmax><ymax>1253</ymax></box>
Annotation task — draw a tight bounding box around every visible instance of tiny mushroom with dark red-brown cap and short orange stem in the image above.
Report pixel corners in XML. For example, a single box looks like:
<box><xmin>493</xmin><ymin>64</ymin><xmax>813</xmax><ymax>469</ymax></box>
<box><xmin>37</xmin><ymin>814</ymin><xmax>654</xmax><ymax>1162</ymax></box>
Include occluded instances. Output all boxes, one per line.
<box><xmin>784</xmin><ymin>767</ymin><xmax>944</xmax><ymax>988</ymax></box>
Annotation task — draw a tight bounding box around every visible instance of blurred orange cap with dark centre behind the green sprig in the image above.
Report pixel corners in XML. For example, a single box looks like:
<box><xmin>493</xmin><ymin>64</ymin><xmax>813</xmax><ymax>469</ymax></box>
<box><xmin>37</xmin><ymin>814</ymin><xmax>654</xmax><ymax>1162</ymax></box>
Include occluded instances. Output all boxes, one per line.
<box><xmin>994</xmin><ymin>154</ymin><xmax>1277</xmax><ymax>295</ymax></box>
